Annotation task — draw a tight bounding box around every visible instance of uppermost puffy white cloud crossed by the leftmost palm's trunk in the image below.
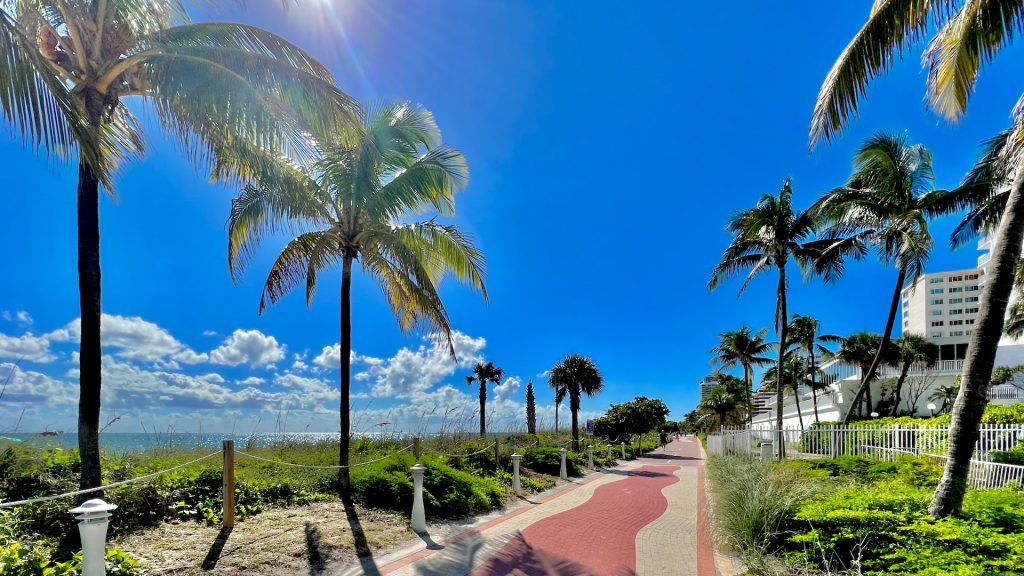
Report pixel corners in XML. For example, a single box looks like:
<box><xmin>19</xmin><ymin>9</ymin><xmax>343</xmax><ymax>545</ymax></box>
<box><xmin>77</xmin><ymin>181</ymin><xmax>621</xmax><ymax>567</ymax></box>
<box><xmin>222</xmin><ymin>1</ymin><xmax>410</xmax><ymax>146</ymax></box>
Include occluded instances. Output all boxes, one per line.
<box><xmin>47</xmin><ymin>314</ymin><xmax>208</xmax><ymax>367</ymax></box>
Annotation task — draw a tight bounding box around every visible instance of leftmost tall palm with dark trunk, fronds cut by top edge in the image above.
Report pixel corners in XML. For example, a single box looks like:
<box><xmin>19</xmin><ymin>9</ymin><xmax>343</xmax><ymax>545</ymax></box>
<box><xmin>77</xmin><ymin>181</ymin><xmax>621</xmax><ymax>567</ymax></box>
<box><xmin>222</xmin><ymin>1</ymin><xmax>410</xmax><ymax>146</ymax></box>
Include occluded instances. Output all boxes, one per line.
<box><xmin>0</xmin><ymin>0</ymin><xmax>356</xmax><ymax>488</ymax></box>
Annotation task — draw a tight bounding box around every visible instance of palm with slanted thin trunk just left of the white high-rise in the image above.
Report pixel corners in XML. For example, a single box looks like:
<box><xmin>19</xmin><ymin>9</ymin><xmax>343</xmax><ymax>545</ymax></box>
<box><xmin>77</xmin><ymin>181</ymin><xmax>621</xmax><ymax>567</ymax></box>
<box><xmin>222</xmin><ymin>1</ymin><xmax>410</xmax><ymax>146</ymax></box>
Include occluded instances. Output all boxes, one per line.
<box><xmin>814</xmin><ymin>134</ymin><xmax>948</xmax><ymax>418</ymax></box>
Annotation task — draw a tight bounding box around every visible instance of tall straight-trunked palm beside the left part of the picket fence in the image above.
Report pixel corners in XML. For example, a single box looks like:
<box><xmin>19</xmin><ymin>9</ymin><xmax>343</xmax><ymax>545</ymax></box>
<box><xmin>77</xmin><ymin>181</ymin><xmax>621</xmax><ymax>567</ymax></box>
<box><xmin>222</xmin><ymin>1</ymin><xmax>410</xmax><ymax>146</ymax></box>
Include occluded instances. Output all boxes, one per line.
<box><xmin>708</xmin><ymin>179</ymin><xmax>864</xmax><ymax>457</ymax></box>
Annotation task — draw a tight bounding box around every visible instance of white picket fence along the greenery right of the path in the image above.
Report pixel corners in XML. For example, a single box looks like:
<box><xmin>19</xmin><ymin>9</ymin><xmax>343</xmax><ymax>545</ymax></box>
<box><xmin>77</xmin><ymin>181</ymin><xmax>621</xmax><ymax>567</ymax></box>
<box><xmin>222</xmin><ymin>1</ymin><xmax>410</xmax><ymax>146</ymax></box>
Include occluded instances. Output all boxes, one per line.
<box><xmin>708</xmin><ymin>424</ymin><xmax>1024</xmax><ymax>488</ymax></box>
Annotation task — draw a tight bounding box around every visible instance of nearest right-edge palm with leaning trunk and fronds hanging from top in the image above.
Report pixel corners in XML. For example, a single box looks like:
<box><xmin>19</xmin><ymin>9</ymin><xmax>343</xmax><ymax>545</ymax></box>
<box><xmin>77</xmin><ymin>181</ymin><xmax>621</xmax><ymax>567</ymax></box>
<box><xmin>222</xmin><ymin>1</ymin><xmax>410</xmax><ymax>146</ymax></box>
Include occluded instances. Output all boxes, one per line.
<box><xmin>810</xmin><ymin>0</ymin><xmax>1024</xmax><ymax>518</ymax></box>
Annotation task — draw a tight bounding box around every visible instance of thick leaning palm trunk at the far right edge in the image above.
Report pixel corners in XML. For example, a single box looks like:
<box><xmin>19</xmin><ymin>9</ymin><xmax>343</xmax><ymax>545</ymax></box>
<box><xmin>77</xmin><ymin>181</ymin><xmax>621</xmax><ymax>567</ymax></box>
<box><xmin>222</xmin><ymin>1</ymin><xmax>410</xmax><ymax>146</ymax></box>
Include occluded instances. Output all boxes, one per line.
<box><xmin>928</xmin><ymin>168</ymin><xmax>1024</xmax><ymax>518</ymax></box>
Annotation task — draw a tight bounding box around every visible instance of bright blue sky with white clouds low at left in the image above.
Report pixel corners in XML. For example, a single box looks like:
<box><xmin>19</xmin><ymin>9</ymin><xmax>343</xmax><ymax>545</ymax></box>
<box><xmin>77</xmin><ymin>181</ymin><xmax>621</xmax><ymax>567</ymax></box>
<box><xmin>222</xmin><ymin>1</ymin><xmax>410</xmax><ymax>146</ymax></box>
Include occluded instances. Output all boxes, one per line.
<box><xmin>0</xmin><ymin>0</ymin><xmax>1021</xmax><ymax>431</ymax></box>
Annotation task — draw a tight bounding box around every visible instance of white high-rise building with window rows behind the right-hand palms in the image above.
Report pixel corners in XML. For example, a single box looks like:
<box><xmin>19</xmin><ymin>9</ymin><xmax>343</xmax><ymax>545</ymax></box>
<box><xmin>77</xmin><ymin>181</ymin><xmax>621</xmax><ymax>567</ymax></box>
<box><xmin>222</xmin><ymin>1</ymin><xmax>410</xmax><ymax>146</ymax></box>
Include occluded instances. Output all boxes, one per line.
<box><xmin>902</xmin><ymin>269</ymin><xmax>984</xmax><ymax>360</ymax></box>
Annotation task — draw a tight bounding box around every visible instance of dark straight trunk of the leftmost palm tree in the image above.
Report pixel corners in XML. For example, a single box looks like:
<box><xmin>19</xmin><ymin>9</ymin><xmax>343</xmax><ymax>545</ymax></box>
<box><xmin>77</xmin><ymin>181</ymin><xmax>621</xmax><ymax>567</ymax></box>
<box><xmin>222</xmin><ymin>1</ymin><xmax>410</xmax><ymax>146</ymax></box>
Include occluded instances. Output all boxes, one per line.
<box><xmin>78</xmin><ymin>88</ymin><xmax>103</xmax><ymax>491</ymax></box>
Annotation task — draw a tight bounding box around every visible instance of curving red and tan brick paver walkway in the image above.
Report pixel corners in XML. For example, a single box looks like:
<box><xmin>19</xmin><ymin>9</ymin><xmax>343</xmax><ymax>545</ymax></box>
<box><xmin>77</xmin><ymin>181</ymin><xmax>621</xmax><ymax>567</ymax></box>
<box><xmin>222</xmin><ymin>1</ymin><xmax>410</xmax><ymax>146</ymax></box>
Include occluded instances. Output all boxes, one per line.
<box><xmin>381</xmin><ymin>438</ymin><xmax>716</xmax><ymax>576</ymax></box>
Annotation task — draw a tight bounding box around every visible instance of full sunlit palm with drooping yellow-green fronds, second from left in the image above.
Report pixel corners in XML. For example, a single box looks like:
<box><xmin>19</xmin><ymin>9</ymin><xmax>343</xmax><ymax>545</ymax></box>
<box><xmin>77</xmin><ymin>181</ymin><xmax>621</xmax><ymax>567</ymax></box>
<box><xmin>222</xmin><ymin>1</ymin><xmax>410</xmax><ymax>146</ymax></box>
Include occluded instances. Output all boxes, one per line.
<box><xmin>227</xmin><ymin>102</ymin><xmax>486</xmax><ymax>494</ymax></box>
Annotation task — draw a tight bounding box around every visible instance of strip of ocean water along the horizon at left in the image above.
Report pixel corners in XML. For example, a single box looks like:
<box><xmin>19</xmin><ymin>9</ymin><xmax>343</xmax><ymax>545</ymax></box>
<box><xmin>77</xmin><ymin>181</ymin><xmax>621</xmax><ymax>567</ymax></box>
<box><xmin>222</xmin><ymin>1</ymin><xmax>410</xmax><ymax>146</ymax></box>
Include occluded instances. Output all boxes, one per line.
<box><xmin>0</xmin><ymin>433</ymin><xmax>348</xmax><ymax>453</ymax></box>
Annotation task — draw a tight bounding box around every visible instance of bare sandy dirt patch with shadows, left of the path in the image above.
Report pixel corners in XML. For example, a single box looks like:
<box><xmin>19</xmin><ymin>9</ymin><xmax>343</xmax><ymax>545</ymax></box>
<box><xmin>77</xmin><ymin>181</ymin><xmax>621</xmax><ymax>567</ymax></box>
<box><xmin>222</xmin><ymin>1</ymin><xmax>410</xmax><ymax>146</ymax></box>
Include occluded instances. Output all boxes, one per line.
<box><xmin>113</xmin><ymin>502</ymin><xmax>416</xmax><ymax>576</ymax></box>
